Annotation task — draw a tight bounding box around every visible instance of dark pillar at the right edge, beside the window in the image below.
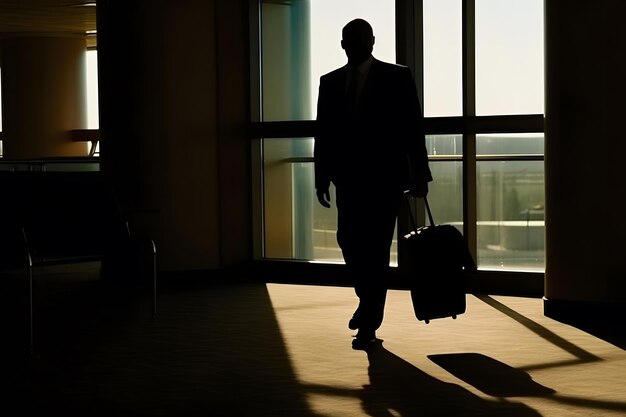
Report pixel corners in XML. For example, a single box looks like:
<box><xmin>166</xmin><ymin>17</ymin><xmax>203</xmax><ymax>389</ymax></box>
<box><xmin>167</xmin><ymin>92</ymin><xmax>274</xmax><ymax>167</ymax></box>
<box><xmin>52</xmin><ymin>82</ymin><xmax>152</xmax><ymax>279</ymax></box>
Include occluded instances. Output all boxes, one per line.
<box><xmin>545</xmin><ymin>0</ymin><xmax>626</xmax><ymax>316</ymax></box>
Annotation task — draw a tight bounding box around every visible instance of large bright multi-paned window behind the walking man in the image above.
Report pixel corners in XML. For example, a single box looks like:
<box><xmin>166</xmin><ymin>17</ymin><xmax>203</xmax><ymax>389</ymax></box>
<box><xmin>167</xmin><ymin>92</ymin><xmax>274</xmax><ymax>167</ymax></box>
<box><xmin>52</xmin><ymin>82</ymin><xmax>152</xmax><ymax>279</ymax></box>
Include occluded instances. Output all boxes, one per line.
<box><xmin>254</xmin><ymin>0</ymin><xmax>544</xmax><ymax>272</ymax></box>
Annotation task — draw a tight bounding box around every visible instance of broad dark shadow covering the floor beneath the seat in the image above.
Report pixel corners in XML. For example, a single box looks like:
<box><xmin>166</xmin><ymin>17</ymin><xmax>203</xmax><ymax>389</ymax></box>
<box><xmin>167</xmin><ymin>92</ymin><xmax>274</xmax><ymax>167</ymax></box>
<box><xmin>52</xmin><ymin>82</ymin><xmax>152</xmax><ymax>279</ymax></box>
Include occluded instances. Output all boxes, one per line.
<box><xmin>0</xmin><ymin>264</ymin><xmax>322</xmax><ymax>417</ymax></box>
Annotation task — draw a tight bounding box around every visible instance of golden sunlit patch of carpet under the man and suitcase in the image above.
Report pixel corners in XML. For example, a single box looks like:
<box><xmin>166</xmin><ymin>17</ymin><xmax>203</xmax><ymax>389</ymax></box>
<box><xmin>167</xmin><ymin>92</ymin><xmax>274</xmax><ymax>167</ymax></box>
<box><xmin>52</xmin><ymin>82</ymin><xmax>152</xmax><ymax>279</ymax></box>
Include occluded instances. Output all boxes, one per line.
<box><xmin>267</xmin><ymin>284</ymin><xmax>626</xmax><ymax>417</ymax></box>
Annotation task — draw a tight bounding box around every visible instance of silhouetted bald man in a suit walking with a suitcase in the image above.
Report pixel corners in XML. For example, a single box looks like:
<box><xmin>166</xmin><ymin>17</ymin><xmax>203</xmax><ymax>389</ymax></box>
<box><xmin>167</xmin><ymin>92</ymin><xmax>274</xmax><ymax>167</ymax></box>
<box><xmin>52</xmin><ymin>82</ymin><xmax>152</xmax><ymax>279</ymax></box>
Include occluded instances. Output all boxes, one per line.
<box><xmin>315</xmin><ymin>19</ymin><xmax>432</xmax><ymax>349</ymax></box>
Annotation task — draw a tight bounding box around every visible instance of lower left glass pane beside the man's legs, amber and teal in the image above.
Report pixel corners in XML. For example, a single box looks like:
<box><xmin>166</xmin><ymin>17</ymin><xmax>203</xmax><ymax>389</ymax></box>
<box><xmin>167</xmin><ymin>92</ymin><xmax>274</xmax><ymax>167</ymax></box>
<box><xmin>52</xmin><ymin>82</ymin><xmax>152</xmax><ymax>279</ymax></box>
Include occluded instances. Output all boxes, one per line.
<box><xmin>263</xmin><ymin>138</ymin><xmax>397</xmax><ymax>266</ymax></box>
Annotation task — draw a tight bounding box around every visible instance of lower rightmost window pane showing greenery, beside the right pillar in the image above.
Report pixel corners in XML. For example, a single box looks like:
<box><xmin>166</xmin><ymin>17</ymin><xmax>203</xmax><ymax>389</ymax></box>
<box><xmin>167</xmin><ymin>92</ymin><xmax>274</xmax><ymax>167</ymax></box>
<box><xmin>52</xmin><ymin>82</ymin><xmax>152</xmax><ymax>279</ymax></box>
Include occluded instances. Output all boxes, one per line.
<box><xmin>477</xmin><ymin>135</ymin><xmax>545</xmax><ymax>272</ymax></box>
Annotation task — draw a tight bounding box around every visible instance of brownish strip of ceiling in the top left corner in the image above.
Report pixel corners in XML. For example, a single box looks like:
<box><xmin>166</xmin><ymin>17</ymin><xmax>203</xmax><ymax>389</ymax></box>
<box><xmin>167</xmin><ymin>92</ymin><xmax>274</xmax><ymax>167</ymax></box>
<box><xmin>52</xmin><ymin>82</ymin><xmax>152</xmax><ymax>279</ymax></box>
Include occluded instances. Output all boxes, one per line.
<box><xmin>0</xmin><ymin>0</ymin><xmax>96</xmax><ymax>47</ymax></box>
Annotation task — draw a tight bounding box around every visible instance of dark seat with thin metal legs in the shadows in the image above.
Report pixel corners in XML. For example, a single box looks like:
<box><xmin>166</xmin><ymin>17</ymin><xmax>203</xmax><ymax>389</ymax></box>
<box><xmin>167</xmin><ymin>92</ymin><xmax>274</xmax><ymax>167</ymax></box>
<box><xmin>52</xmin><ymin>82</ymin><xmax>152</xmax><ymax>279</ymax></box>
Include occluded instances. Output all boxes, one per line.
<box><xmin>7</xmin><ymin>171</ymin><xmax>157</xmax><ymax>353</ymax></box>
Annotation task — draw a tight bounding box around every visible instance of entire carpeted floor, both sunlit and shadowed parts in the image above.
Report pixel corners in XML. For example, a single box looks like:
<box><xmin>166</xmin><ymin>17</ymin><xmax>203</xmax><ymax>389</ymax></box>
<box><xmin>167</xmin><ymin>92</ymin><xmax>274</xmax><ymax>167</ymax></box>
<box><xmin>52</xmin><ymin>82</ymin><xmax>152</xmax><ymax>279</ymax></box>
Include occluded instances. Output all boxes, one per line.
<box><xmin>0</xmin><ymin>265</ymin><xmax>626</xmax><ymax>417</ymax></box>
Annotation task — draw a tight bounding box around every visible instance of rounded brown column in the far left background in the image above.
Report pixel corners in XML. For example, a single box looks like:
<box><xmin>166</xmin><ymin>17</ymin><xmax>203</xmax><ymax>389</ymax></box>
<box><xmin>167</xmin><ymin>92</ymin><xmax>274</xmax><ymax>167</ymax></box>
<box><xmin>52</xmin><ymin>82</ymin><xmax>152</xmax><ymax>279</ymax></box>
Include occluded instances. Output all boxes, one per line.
<box><xmin>2</xmin><ymin>36</ymin><xmax>88</xmax><ymax>159</ymax></box>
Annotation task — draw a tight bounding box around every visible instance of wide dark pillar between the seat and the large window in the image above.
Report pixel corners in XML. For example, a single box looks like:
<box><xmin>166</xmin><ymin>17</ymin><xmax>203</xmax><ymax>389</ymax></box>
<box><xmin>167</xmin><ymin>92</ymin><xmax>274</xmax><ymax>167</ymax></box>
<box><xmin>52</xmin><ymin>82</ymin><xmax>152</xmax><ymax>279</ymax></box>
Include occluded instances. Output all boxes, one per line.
<box><xmin>97</xmin><ymin>0</ymin><xmax>251</xmax><ymax>271</ymax></box>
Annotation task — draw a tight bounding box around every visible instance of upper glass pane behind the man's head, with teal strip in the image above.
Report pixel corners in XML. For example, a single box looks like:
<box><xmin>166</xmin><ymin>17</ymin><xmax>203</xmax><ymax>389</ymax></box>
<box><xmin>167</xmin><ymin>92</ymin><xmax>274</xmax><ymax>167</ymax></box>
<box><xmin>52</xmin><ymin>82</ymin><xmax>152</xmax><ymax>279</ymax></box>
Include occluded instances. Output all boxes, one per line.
<box><xmin>261</xmin><ymin>0</ymin><xmax>396</xmax><ymax>121</ymax></box>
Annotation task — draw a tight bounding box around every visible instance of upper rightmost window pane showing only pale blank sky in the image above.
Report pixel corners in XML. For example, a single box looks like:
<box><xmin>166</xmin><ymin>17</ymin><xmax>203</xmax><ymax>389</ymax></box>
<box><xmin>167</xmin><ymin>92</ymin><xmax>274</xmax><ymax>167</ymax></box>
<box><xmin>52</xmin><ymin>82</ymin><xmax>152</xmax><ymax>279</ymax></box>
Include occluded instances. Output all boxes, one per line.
<box><xmin>476</xmin><ymin>0</ymin><xmax>544</xmax><ymax>115</ymax></box>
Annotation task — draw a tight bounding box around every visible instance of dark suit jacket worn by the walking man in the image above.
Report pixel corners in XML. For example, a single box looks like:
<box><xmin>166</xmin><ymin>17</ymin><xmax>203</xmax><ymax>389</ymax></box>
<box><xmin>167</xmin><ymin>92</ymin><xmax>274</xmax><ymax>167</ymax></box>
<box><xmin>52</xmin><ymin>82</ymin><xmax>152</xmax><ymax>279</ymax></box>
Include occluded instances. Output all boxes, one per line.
<box><xmin>314</xmin><ymin>59</ymin><xmax>432</xmax><ymax>191</ymax></box>
